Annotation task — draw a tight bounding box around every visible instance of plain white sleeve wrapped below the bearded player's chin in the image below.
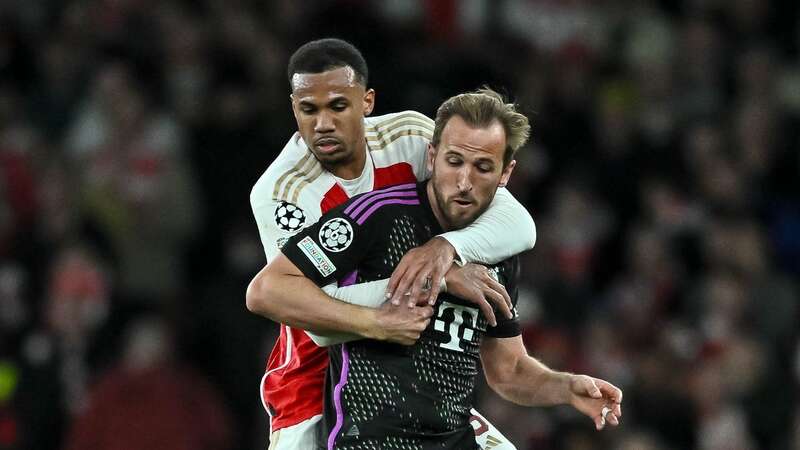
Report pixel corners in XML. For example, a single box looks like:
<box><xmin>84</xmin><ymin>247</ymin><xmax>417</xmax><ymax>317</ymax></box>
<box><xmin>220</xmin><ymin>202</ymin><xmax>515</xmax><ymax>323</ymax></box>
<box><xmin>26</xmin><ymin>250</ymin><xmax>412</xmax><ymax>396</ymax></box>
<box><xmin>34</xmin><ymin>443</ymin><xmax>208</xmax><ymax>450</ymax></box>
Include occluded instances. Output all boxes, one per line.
<box><xmin>440</xmin><ymin>188</ymin><xmax>536</xmax><ymax>264</ymax></box>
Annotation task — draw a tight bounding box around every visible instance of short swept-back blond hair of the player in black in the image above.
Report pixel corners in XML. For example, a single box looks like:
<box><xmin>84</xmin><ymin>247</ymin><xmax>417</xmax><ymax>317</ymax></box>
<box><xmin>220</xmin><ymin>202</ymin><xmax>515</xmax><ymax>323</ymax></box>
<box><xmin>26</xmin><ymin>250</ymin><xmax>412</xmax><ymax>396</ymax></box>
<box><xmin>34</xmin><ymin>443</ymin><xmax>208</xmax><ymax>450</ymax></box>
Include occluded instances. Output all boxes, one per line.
<box><xmin>431</xmin><ymin>87</ymin><xmax>531</xmax><ymax>167</ymax></box>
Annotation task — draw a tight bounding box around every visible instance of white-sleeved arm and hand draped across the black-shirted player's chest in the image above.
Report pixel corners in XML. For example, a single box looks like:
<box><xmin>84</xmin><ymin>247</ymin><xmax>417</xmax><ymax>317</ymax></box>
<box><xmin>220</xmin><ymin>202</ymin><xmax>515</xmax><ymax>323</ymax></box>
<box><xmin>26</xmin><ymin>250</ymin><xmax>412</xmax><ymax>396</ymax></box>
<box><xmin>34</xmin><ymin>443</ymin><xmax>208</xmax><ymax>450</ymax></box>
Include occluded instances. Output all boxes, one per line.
<box><xmin>387</xmin><ymin>188</ymin><xmax>536</xmax><ymax>303</ymax></box>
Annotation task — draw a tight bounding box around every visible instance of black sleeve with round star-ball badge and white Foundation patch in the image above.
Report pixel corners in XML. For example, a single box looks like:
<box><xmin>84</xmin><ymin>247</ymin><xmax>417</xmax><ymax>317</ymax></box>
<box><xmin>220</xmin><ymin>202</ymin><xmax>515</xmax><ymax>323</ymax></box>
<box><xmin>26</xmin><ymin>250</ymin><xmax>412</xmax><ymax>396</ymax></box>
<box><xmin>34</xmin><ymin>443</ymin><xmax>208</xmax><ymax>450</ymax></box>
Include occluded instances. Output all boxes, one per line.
<box><xmin>281</xmin><ymin>202</ymin><xmax>373</xmax><ymax>286</ymax></box>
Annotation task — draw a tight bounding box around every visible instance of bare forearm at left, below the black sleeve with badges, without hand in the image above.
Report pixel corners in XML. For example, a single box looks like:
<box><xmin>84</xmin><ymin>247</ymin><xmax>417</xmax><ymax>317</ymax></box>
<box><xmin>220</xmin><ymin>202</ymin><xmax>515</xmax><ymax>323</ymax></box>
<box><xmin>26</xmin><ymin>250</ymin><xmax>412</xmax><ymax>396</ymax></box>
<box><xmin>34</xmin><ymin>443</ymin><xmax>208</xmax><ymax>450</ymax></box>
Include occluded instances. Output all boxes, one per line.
<box><xmin>247</xmin><ymin>269</ymin><xmax>375</xmax><ymax>337</ymax></box>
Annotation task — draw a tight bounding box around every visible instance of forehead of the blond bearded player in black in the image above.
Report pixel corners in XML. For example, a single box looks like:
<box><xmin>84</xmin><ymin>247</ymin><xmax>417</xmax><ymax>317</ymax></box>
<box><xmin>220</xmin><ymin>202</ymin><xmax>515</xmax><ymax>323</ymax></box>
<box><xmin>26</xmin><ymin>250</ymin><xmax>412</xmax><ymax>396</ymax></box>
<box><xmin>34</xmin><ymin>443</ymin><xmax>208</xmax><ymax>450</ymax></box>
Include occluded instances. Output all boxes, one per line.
<box><xmin>440</xmin><ymin>116</ymin><xmax>506</xmax><ymax>161</ymax></box>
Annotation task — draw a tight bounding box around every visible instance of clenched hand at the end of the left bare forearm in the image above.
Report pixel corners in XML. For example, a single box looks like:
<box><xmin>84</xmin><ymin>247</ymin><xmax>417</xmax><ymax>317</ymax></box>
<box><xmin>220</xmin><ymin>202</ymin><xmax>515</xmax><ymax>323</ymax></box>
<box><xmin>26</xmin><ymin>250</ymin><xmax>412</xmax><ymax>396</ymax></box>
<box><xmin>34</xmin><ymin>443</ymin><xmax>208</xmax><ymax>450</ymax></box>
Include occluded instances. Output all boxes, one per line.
<box><xmin>370</xmin><ymin>302</ymin><xmax>433</xmax><ymax>345</ymax></box>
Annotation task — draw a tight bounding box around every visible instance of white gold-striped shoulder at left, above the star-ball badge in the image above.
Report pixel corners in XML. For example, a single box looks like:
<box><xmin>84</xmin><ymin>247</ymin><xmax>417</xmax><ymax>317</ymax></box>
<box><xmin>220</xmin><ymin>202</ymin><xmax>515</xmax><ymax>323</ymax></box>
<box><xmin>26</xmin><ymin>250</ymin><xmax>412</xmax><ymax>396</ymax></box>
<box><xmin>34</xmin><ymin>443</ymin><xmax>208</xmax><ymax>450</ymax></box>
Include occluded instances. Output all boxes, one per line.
<box><xmin>250</xmin><ymin>133</ymin><xmax>322</xmax><ymax>207</ymax></box>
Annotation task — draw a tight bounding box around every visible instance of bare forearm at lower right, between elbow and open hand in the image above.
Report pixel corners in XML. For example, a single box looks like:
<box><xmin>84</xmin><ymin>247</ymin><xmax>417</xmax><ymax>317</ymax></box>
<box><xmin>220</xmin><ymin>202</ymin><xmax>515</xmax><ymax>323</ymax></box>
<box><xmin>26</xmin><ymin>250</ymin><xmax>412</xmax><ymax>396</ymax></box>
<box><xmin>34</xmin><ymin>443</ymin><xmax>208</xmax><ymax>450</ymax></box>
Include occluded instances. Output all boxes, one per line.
<box><xmin>490</xmin><ymin>356</ymin><xmax>572</xmax><ymax>406</ymax></box>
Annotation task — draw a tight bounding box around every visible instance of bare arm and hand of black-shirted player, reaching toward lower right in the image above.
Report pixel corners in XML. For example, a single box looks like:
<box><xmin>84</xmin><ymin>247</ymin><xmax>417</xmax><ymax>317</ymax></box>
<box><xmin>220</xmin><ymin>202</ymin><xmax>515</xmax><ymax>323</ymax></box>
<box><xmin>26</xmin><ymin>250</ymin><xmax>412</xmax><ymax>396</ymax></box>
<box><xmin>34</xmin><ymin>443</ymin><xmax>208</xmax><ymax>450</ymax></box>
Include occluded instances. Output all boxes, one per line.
<box><xmin>480</xmin><ymin>335</ymin><xmax>622</xmax><ymax>430</ymax></box>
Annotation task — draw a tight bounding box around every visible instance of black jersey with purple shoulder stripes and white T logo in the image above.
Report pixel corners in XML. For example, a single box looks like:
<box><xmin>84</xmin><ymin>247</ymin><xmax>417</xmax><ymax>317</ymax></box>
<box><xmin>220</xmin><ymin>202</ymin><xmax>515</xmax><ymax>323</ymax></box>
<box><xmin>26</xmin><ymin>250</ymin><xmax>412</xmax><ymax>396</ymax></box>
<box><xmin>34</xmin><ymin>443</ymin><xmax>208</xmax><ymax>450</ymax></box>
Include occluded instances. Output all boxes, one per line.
<box><xmin>283</xmin><ymin>183</ymin><xmax>520</xmax><ymax>450</ymax></box>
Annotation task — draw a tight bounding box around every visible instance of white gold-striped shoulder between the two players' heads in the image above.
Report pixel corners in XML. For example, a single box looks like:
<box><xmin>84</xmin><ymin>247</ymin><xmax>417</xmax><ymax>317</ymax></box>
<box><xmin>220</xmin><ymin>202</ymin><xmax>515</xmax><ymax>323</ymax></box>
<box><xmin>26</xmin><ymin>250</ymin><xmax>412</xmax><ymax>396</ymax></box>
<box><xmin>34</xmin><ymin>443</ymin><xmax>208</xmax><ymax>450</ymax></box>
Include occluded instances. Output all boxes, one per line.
<box><xmin>364</xmin><ymin>111</ymin><xmax>434</xmax><ymax>150</ymax></box>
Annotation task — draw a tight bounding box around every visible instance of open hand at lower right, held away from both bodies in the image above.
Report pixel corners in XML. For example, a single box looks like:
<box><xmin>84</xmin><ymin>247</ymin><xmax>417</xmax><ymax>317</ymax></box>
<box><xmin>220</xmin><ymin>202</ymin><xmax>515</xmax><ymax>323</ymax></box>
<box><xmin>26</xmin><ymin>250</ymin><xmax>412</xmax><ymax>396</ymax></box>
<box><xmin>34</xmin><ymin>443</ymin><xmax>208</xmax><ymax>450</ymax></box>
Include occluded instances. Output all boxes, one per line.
<box><xmin>569</xmin><ymin>375</ymin><xmax>622</xmax><ymax>430</ymax></box>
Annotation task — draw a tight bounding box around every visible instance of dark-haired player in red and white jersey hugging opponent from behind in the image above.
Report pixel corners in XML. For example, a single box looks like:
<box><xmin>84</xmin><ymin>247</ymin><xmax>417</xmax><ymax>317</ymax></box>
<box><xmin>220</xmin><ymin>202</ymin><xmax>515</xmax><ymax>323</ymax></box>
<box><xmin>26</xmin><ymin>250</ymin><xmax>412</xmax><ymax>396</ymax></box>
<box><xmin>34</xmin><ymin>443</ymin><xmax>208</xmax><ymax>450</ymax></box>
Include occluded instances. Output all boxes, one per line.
<box><xmin>248</xmin><ymin>39</ymin><xmax>536</xmax><ymax>449</ymax></box>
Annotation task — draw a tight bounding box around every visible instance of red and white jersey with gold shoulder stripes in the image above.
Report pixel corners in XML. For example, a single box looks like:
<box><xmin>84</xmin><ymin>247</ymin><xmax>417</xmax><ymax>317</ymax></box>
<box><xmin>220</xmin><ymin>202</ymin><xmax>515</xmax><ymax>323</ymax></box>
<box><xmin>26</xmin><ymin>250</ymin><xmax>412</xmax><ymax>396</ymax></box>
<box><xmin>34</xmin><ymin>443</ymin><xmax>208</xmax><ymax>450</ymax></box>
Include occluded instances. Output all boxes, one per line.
<box><xmin>250</xmin><ymin>111</ymin><xmax>433</xmax><ymax>431</ymax></box>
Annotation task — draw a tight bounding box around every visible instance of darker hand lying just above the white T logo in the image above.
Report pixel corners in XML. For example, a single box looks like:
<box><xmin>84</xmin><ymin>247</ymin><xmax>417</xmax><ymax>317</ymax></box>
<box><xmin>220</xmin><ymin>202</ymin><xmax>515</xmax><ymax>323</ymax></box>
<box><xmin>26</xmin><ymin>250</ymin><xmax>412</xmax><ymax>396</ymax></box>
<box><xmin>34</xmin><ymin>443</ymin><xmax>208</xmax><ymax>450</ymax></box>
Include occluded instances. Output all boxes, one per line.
<box><xmin>445</xmin><ymin>263</ymin><xmax>514</xmax><ymax>326</ymax></box>
